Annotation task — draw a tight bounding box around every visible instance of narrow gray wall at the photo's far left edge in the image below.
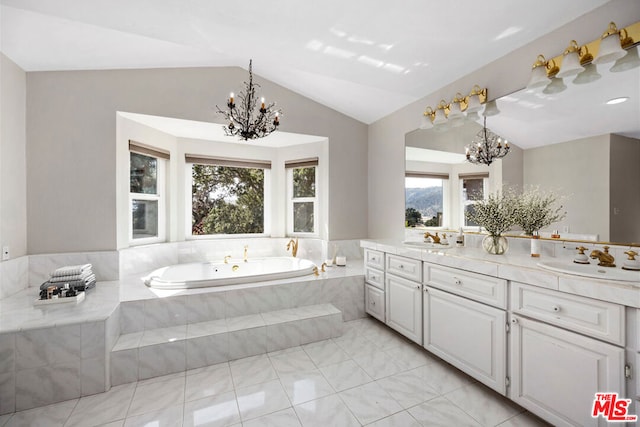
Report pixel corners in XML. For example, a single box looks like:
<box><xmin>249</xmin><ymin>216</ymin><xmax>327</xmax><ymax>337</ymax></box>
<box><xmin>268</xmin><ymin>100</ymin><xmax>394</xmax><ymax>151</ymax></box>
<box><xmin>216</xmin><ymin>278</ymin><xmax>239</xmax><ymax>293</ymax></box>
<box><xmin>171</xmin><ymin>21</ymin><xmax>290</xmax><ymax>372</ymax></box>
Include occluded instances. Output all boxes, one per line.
<box><xmin>0</xmin><ymin>53</ymin><xmax>27</xmax><ymax>258</ymax></box>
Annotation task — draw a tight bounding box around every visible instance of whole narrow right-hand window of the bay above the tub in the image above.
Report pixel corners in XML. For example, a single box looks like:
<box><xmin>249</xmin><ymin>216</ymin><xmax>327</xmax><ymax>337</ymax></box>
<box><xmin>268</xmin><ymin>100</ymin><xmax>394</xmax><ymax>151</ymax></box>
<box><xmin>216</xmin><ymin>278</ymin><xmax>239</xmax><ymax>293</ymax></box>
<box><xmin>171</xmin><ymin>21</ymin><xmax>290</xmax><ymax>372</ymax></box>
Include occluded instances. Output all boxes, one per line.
<box><xmin>285</xmin><ymin>159</ymin><xmax>318</xmax><ymax>234</ymax></box>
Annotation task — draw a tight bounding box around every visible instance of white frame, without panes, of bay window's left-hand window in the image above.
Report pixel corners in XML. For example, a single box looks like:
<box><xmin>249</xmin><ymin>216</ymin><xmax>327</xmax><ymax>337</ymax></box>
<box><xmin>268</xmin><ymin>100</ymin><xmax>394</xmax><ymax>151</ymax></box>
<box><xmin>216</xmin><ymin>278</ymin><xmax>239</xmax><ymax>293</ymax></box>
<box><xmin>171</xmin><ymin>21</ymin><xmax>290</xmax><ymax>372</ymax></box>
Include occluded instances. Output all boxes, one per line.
<box><xmin>128</xmin><ymin>150</ymin><xmax>168</xmax><ymax>246</ymax></box>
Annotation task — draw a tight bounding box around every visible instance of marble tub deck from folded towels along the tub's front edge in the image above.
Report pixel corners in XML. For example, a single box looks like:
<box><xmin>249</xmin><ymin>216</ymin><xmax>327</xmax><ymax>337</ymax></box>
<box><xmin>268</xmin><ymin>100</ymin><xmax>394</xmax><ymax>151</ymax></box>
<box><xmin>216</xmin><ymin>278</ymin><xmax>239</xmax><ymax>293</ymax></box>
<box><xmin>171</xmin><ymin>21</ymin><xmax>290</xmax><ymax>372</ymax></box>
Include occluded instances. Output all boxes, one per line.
<box><xmin>0</xmin><ymin>259</ymin><xmax>364</xmax><ymax>333</ymax></box>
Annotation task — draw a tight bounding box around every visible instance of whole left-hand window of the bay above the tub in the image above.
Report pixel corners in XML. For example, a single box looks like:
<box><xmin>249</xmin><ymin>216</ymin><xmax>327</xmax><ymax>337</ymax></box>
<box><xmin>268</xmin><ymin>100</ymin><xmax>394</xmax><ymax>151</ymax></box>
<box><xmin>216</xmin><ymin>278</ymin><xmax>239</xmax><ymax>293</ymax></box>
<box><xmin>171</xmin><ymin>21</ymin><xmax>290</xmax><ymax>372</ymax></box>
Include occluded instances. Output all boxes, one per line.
<box><xmin>129</xmin><ymin>141</ymin><xmax>169</xmax><ymax>244</ymax></box>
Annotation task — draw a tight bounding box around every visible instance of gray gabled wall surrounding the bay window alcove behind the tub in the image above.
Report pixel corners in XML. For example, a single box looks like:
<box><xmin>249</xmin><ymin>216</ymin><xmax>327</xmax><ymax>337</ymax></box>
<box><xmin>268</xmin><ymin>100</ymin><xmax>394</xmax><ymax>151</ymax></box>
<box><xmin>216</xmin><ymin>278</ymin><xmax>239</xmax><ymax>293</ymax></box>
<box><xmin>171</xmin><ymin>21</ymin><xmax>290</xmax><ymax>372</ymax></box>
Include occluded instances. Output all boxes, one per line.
<box><xmin>27</xmin><ymin>68</ymin><xmax>368</xmax><ymax>254</ymax></box>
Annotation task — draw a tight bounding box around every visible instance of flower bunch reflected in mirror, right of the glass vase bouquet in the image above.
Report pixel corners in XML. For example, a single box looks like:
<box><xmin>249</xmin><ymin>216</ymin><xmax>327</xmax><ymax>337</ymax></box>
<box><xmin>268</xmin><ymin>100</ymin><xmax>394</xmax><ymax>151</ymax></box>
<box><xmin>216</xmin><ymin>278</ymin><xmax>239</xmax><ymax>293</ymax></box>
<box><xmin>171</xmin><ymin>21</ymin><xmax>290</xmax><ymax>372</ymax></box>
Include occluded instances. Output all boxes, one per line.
<box><xmin>515</xmin><ymin>187</ymin><xmax>567</xmax><ymax>236</ymax></box>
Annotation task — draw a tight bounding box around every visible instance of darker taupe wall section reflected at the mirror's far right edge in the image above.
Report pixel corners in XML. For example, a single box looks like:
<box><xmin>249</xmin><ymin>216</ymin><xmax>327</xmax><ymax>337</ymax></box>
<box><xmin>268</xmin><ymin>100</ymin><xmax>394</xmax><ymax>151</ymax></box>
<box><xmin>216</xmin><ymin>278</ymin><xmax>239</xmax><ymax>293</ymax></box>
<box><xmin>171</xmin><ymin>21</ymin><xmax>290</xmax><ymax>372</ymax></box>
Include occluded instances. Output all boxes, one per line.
<box><xmin>609</xmin><ymin>135</ymin><xmax>640</xmax><ymax>242</ymax></box>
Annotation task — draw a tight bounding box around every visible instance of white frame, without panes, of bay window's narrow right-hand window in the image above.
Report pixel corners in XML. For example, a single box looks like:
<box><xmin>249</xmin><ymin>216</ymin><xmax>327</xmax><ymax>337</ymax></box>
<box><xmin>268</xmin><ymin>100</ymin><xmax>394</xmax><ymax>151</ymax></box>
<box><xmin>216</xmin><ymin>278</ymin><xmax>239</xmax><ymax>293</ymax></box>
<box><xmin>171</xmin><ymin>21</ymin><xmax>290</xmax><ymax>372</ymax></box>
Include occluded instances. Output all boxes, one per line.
<box><xmin>285</xmin><ymin>158</ymin><xmax>320</xmax><ymax>237</ymax></box>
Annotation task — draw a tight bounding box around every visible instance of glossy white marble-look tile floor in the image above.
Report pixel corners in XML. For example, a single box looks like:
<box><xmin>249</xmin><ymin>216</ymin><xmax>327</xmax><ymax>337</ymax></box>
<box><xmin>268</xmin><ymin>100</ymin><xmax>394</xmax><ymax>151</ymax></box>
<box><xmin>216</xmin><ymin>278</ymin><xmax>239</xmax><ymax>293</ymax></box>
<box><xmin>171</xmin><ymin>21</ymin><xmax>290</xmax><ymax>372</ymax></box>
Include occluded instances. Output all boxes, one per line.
<box><xmin>0</xmin><ymin>319</ymin><xmax>546</xmax><ymax>427</ymax></box>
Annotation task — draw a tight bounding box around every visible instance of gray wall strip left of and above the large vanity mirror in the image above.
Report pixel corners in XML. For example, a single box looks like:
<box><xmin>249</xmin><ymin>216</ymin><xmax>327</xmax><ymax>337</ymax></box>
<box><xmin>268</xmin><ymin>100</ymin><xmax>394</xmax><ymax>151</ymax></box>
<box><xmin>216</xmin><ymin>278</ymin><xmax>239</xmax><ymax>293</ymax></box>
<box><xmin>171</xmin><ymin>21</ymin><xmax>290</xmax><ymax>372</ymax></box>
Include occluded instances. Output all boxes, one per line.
<box><xmin>368</xmin><ymin>0</ymin><xmax>640</xmax><ymax>239</ymax></box>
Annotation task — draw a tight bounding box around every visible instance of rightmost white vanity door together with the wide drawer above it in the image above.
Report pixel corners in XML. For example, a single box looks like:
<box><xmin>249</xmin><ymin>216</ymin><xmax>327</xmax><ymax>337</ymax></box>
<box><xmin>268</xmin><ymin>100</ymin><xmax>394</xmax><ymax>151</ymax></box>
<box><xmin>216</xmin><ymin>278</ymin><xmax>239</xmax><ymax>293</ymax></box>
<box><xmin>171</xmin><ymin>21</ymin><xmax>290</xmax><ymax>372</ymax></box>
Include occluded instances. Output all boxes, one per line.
<box><xmin>509</xmin><ymin>282</ymin><xmax>625</xmax><ymax>426</ymax></box>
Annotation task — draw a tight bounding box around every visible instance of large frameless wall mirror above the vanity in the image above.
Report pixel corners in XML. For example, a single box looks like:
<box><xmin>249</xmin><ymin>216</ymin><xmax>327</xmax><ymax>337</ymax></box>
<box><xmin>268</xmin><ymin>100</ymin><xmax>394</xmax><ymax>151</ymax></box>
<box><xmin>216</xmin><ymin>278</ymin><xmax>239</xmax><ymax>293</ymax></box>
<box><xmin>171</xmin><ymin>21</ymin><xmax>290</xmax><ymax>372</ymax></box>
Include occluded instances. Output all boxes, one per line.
<box><xmin>405</xmin><ymin>56</ymin><xmax>640</xmax><ymax>243</ymax></box>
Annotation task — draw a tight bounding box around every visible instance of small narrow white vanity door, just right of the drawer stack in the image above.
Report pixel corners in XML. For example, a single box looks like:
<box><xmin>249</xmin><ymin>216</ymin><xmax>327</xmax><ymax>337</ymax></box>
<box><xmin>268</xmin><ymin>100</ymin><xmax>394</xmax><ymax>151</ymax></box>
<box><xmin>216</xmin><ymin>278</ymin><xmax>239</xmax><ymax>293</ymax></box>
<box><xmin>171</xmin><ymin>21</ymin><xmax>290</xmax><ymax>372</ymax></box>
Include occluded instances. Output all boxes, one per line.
<box><xmin>385</xmin><ymin>274</ymin><xmax>422</xmax><ymax>344</ymax></box>
